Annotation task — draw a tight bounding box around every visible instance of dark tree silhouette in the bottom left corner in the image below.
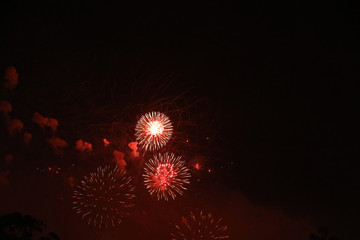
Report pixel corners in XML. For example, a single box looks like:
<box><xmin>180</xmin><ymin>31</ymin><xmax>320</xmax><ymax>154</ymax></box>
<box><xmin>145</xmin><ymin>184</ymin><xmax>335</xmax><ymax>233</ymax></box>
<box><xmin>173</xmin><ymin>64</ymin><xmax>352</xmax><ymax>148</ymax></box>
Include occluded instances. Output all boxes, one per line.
<box><xmin>0</xmin><ymin>212</ymin><xmax>60</xmax><ymax>240</ymax></box>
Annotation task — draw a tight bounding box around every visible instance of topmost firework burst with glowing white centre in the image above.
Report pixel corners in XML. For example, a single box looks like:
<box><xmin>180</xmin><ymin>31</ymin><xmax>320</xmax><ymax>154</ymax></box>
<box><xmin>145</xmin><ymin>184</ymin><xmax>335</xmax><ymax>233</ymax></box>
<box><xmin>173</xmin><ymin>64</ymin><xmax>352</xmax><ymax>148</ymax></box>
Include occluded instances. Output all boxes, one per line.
<box><xmin>135</xmin><ymin>112</ymin><xmax>173</xmax><ymax>151</ymax></box>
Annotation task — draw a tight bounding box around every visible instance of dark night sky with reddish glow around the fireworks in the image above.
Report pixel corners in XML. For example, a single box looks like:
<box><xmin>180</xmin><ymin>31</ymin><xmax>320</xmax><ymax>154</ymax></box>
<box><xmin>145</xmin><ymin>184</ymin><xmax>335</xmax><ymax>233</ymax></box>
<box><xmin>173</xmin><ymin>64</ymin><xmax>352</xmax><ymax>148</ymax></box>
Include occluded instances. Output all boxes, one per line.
<box><xmin>0</xmin><ymin>1</ymin><xmax>360</xmax><ymax>240</ymax></box>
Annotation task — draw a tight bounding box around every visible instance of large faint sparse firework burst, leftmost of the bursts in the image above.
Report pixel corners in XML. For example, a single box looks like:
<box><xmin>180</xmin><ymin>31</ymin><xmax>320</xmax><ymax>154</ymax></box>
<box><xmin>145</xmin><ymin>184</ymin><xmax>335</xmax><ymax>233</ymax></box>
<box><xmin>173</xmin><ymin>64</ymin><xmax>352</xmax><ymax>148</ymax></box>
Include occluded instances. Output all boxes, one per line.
<box><xmin>73</xmin><ymin>166</ymin><xmax>135</xmax><ymax>228</ymax></box>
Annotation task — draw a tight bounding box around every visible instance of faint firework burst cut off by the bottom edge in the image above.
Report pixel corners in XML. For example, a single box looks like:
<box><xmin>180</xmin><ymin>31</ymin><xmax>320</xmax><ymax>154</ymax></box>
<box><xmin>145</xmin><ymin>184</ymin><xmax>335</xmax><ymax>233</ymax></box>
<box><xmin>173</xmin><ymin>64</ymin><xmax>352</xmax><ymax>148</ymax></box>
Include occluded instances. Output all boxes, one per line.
<box><xmin>170</xmin><ymin>210</ymin><xmax>229</xmax><ymax>240</ymax></box>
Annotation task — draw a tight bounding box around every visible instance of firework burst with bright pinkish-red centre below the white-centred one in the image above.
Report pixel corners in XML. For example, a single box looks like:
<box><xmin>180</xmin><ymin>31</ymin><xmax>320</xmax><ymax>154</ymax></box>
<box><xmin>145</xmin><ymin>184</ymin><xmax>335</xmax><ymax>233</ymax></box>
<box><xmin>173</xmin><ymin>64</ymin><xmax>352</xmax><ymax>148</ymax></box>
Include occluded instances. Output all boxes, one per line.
<box><xmin>143</xmin><ymin>153</ymin><xmax>190</xmax><ymax>201</ymax></box>
